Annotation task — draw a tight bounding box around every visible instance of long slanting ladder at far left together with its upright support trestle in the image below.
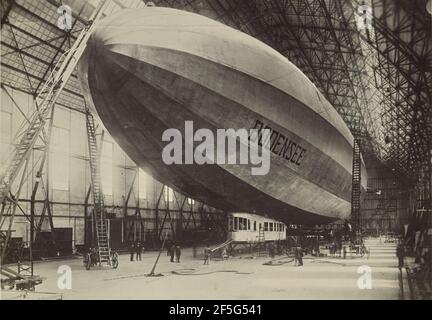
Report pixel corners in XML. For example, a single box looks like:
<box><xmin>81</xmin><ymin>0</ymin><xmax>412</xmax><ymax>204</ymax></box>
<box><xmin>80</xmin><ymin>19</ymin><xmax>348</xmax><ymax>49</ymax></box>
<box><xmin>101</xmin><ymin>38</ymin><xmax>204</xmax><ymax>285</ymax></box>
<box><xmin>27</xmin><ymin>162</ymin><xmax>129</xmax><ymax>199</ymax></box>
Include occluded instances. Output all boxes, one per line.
<box><xmin>0</xmin><ymin>1</ymin><xmax>106</xmax><ymax>282</ymax></box>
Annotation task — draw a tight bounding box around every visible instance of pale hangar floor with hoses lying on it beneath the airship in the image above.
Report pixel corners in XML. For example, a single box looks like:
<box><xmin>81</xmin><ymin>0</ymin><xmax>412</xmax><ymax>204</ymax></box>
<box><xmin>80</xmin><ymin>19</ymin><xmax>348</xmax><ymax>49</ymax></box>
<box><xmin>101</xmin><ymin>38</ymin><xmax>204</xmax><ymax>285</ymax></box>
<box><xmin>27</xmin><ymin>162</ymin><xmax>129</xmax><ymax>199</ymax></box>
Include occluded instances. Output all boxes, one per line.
<box><xmin>0</xmin><ymin>239</ymin><xmax>400</xmax><ymax>300</ymax></box>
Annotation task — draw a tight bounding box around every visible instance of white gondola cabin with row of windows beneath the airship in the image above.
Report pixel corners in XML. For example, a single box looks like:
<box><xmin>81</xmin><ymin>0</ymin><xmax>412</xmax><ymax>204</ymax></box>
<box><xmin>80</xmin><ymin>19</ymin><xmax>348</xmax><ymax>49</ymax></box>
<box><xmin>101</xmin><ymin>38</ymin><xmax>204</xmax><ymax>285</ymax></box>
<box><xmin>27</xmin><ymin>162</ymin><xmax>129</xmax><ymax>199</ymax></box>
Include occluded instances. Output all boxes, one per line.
<box><xmin>228</xmin><ymin>213</ymin><xmax>286</xmax><ymax>242</ymax></box>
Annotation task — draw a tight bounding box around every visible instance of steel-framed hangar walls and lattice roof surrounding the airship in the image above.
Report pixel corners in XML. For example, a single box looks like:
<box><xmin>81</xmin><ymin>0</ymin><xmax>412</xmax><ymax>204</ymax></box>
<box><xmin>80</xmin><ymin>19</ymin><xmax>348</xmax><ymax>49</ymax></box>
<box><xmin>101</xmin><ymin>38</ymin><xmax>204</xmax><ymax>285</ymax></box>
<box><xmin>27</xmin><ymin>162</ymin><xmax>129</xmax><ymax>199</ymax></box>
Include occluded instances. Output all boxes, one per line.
<box><xmin>0</xmin><ymin>0</ymin><xmax>432</xmax><ymax>300</ymax></box>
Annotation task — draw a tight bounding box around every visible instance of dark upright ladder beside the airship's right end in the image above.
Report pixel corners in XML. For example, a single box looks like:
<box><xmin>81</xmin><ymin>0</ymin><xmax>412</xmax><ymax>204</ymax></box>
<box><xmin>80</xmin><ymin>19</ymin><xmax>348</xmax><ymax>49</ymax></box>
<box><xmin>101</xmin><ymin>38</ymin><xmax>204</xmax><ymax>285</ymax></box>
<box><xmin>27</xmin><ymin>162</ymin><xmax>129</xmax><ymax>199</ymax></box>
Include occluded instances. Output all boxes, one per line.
<box><xmin>351</xmin><ymin>137</ymin><xmax>361</xmax><ymax>235</ymax></box>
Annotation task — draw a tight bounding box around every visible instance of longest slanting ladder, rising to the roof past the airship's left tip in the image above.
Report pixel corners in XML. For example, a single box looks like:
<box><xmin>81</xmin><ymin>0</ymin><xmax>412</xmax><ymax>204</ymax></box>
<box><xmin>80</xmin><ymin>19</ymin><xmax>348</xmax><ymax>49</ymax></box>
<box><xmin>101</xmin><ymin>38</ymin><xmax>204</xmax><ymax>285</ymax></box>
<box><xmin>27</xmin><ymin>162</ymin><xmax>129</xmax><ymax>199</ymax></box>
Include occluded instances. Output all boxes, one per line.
<box><xmin>0</xmin><ymin>0</ymin><xmax>108</xmax><ymax>262</ymax></box>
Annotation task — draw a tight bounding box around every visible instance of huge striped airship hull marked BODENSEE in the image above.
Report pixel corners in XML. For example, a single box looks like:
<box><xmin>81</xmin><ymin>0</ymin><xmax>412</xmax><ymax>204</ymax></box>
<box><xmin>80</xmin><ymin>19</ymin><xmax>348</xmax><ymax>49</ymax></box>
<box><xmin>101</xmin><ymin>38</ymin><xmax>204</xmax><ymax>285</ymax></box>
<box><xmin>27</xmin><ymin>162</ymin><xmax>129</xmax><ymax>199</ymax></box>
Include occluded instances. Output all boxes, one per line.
<box><xmin>78</xmin><ymin>7</ymin><xmax>367</xmax><ymax>224</ymax></box>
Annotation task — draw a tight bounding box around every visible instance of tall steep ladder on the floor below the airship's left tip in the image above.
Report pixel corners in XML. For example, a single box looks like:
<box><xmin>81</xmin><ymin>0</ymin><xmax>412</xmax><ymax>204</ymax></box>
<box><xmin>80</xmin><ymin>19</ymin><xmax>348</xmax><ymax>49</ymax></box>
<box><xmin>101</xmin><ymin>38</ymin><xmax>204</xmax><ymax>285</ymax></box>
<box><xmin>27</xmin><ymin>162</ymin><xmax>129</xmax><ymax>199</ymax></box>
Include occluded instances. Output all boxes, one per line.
<box><xmin>86</xmin><ymin>109</ymin><xmax>110</xmax><ymax>264</ymax></box>
